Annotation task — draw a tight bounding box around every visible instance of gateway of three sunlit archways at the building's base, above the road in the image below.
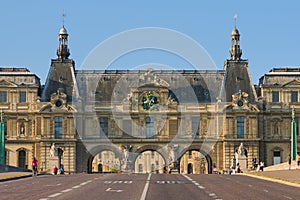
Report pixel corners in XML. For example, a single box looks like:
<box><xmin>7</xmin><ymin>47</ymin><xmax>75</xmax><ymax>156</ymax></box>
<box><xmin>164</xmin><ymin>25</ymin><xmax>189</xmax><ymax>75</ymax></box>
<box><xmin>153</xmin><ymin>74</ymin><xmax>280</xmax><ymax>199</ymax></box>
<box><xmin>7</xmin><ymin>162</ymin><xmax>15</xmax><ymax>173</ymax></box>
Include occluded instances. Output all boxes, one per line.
<box><xmin>87</xmin><ymin>145</ymin><xmax>212</xmax><ymax>174</ymax></box>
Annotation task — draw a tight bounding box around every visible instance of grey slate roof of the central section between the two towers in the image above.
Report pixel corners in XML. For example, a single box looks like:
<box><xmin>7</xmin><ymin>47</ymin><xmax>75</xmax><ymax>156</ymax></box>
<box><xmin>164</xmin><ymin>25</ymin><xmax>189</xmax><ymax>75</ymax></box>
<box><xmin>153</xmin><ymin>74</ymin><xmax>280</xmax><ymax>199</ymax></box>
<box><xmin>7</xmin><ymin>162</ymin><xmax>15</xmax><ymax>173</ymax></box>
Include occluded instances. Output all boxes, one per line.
<box><xmin>75</xmin><ymin>70</ymin><xmax>225</xmax><ymax>103</ymax></box>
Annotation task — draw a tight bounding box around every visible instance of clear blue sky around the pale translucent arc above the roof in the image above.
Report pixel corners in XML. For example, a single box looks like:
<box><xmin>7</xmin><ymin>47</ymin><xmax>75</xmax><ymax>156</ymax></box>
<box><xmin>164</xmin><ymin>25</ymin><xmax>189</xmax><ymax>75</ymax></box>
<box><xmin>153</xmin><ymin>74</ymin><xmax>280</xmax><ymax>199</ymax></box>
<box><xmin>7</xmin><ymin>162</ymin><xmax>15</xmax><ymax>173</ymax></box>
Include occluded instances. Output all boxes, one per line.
<box><xmin>0</xmin><ymin>0</ymin><xmax>300</xmax><ymax>84</ymax></box>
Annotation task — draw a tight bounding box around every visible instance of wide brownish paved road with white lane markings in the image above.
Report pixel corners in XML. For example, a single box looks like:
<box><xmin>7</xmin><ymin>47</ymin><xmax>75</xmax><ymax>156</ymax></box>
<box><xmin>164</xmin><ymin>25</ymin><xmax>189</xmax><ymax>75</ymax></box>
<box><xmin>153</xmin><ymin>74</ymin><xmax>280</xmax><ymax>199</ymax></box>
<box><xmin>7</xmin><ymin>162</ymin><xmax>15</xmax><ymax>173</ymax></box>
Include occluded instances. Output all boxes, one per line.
<box><xmin>0</xmin><ymin>174</ymin><xmax>300</xmax><ymax>200</ymax></box>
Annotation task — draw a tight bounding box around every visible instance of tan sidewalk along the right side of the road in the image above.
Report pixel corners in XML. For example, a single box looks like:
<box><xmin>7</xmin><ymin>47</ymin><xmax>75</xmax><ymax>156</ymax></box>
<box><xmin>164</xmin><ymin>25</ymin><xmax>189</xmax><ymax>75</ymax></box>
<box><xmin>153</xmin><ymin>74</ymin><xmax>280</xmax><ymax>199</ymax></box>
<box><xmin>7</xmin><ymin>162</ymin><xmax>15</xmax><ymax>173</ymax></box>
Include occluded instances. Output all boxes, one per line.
<box><xmin>243</xmin><ymin>169</ymin><xmax>300</xmax><ymax>187</ymax></box>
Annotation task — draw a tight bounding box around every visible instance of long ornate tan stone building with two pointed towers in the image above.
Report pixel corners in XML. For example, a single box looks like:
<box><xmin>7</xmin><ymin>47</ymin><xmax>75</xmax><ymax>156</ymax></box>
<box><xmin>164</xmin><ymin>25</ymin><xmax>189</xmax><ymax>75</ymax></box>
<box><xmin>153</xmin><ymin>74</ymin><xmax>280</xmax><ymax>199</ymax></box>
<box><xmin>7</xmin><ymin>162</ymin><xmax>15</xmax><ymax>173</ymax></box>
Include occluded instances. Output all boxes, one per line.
<box><xmin>0</xmin><ymin>23</ymin><xmax>300</xmax><ymax>173</ymax></box>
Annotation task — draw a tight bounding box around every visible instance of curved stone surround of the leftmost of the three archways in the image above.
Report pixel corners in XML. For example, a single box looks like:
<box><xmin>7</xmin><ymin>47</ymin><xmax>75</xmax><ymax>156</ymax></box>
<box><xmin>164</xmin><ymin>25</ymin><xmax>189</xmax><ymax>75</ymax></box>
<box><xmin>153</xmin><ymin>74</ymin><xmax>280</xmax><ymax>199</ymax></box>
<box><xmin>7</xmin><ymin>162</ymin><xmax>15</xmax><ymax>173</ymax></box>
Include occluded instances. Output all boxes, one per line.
<box><xmin>87</xmin><ymin>145</ymin><xmax>123</xmax><ymax>173</ymax></box>
